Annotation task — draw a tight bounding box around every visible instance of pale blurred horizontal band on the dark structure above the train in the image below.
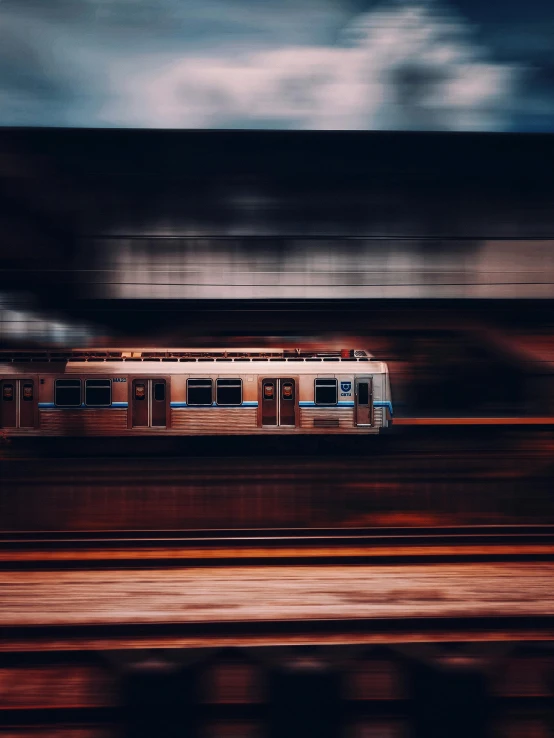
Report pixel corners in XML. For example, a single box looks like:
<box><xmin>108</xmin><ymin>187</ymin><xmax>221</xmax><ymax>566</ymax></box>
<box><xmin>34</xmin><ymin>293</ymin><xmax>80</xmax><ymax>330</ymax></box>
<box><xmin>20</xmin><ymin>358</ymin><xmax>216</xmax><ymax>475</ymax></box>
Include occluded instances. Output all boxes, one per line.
<box><xmin>95</xmin><ymin>236</ymin><xmax>554</xmax><ymax>300</ymax></box>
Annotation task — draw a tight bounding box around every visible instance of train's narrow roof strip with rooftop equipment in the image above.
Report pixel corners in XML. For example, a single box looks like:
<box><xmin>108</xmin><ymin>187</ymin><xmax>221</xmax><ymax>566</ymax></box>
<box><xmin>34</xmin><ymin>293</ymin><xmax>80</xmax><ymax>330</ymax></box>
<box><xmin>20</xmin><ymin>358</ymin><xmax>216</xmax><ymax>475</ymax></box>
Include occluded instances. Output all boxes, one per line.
<box><xmin>0</xmin><ymin>348</ymin><xmax>373</xmax><ymax>363</ymax></box>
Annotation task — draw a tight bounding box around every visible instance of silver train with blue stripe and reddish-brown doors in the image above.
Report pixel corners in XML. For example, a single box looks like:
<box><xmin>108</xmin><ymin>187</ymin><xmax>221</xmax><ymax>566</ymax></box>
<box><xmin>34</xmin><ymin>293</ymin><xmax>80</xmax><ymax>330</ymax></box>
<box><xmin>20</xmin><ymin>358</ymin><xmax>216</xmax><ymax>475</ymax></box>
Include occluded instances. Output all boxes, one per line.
<box><xmin>0</xmin><ymin>349</ymin><xmax>392</xmax><ymax>436</ymax></box>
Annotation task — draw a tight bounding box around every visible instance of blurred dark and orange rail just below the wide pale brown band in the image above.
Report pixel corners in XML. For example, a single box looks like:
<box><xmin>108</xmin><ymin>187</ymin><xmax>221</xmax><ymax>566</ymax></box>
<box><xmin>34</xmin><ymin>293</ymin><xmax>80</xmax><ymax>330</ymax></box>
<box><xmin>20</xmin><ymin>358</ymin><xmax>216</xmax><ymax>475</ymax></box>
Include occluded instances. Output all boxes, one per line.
<box><xmin>5</xmin><ymin>615</ymin><xmax>554</xmax><ymax>654</ymax></box>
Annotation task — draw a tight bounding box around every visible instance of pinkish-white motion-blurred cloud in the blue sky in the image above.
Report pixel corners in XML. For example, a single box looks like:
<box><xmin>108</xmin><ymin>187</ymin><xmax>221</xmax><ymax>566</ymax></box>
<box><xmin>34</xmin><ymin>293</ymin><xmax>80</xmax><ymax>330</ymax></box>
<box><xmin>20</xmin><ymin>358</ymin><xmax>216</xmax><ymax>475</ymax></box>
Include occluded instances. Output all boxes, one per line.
<box><xmin>100</xmin><ymin>4</ymin><xmax>522</xmax><ymax>130</ymax></box>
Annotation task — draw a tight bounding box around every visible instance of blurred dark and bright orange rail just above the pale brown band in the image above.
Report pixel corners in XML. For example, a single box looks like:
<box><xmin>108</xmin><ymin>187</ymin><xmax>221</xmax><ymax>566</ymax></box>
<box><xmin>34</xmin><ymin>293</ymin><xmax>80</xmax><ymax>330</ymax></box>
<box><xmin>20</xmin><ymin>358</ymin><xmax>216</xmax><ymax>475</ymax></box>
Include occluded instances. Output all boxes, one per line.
<box><xmin>0</xmin><ymin>525</ymin><xmax>554</xmax><ymax>570</ymax></box>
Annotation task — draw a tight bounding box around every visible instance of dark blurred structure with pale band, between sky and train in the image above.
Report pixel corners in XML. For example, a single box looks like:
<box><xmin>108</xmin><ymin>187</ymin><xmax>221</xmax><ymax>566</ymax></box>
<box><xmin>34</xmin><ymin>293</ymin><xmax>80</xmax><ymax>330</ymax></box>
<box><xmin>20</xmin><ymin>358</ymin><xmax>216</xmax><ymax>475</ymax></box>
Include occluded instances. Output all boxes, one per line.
<box><xmin>0</xmin><ymin>128</ymin><xmax>554</xmax><ymax>418</ymax></box>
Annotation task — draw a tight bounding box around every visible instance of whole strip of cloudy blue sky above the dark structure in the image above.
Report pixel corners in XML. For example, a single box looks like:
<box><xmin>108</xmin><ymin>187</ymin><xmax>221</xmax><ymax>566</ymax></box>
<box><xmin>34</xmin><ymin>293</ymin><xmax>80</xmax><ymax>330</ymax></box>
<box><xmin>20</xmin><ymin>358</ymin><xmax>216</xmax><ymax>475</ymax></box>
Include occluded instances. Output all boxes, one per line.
<box><xmin>0</xmin><ymin>0</ymin><xmax>554</xmax><ymax>132</ymax></box>
